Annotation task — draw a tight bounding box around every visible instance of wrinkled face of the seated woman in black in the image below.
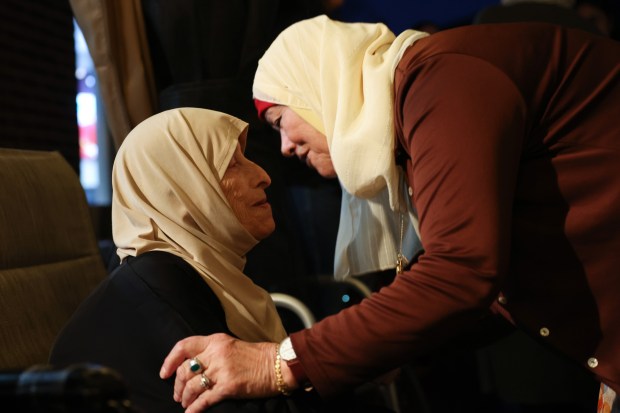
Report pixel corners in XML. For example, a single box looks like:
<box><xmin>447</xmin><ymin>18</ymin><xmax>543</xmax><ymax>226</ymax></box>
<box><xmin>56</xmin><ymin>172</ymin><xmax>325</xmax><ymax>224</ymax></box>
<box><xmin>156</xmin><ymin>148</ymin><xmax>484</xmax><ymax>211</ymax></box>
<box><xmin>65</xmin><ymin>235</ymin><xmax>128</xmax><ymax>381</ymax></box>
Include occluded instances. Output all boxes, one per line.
<box><xmin>220</xmin><ymin>144</ymin><xmax>276</xmax><ymax>240</ymax></box>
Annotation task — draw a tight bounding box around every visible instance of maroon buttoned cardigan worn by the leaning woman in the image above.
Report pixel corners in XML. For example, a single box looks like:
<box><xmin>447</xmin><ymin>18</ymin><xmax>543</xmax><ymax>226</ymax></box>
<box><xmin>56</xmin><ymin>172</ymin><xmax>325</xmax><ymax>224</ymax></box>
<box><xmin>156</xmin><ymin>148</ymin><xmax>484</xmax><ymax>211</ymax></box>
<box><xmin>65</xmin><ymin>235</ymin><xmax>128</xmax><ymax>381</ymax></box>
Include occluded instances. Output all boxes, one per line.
<box><xmin>292</xmin><ymin>23</ymin><xmax>620</xmax><ymax>395</ymax></box>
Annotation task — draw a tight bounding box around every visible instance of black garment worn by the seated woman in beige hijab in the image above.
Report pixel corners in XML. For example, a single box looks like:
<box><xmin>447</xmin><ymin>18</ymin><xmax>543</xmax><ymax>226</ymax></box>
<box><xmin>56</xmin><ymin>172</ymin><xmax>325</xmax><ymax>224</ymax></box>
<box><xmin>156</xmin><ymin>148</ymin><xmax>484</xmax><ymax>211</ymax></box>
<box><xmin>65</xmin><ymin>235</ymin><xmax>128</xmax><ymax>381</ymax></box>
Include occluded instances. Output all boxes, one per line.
<box><xmin>50</xmin><ymin>252</ymin><xmax>382</xmax><ymax>413</ymax></box>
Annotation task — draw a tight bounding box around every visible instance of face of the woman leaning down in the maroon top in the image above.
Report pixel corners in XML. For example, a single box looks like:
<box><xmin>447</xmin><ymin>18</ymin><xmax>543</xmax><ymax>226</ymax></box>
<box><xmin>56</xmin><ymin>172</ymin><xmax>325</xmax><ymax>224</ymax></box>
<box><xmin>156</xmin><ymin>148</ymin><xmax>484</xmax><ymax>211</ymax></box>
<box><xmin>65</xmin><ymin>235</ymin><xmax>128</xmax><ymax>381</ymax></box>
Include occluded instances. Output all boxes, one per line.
<box><xmin>265</xmin><ymin>105</ymin><xmax>336</xmax><ymax>178</ymax></box>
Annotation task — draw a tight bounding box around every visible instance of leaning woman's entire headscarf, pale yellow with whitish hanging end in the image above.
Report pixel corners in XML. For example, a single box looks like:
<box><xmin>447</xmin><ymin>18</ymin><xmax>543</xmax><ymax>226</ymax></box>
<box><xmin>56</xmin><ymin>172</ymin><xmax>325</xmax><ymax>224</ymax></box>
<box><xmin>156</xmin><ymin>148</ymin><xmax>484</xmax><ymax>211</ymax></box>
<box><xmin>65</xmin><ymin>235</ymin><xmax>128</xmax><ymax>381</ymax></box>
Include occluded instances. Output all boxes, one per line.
<box><xmin>253</xmin><ymin>16</ymin><xmax>428</xmax><ymax>278</ymax></box>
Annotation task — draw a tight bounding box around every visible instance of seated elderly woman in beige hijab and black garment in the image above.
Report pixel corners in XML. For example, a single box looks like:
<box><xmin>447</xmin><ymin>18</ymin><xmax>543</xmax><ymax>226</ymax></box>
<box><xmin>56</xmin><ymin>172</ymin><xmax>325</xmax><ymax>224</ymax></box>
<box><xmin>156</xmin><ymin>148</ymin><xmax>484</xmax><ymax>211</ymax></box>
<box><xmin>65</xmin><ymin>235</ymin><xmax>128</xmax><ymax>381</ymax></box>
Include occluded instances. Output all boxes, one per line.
<box><xmin>50</xmin><ymin>108</ymin><xmax>366</xmax><ymax>413</ymax></box>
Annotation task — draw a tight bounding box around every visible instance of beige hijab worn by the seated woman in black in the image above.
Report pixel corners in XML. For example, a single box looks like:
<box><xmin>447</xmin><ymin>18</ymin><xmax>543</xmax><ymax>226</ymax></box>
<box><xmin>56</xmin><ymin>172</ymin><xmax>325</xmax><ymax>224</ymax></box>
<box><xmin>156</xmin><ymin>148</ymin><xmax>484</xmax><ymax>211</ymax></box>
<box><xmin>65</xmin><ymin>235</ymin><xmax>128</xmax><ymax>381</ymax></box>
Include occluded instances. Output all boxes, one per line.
<box><xmin>112</xmin><ymin>108</ymin><xmax>286</xmax><ymax>341</ymax></box>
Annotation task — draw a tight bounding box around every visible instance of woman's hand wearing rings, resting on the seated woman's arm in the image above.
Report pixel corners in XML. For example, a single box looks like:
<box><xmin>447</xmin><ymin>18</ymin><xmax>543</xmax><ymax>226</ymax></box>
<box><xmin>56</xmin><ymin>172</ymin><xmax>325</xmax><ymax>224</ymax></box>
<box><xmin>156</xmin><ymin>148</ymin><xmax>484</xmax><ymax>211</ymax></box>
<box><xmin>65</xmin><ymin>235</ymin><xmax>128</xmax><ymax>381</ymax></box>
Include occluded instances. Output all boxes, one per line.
<box><xmin>159</xmin><ymin>333</ymin><xmax>278</xmax><ymax>413</ymax></box>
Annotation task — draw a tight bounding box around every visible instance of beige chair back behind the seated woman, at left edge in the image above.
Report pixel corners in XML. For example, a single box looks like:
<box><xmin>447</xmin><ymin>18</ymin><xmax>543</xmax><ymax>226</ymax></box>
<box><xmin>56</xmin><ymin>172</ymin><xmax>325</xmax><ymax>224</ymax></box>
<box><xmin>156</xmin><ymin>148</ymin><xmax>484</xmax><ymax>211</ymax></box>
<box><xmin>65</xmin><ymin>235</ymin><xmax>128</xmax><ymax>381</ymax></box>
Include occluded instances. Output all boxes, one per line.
<box><xmin>0</xmin><ymin>149</ymin><xmax>106</xmax><ymax>370</ymax></box>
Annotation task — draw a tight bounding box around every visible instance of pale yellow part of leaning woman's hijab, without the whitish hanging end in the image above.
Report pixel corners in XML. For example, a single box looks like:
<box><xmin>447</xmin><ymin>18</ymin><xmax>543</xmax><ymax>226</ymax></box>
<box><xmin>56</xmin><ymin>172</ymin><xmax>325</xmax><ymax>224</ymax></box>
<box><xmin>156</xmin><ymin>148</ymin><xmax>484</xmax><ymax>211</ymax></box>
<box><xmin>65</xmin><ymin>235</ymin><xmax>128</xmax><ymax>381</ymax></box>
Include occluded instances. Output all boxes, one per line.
<box><xmin>253</xmin><ymin>16</ymin><xmax>427</xmax><ymax>210</ymax></box>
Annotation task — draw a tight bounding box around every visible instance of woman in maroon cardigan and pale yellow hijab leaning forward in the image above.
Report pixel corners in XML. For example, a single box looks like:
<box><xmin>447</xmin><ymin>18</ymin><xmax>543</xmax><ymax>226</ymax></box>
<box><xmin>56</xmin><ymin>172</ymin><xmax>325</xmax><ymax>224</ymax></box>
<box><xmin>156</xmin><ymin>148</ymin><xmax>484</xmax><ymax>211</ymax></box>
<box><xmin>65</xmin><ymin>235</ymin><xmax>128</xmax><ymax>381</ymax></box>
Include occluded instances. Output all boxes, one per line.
<box><xmin>162</xmin><ymin>16</ymin><xmax>620</xmax><ymax>412</ymax></box>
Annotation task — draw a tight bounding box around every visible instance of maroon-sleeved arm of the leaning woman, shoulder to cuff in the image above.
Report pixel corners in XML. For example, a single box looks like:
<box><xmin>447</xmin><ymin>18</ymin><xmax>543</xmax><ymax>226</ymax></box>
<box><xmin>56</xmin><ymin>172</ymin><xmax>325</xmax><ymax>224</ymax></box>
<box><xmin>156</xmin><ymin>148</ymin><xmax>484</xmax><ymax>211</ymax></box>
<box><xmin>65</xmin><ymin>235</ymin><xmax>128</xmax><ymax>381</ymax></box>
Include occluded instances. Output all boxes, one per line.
<box><xmin>291</xmin><ymin>55</ymin><xmax>525</xmax><ymax>395</ymax></box>
